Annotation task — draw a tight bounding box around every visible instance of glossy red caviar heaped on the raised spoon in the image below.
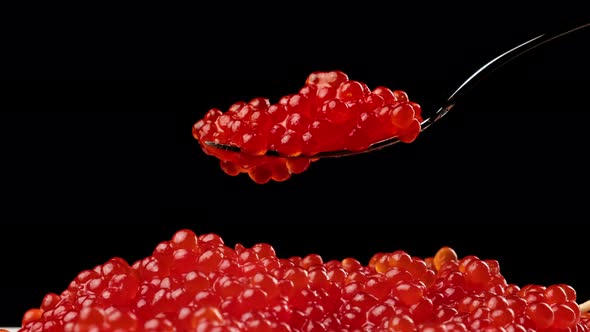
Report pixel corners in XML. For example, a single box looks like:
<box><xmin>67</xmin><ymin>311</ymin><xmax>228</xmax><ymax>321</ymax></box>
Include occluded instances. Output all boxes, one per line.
<box><xmin>193</xmin><ymin>71</ymin><xmax>422</xmax><ymax>183</ymax></box>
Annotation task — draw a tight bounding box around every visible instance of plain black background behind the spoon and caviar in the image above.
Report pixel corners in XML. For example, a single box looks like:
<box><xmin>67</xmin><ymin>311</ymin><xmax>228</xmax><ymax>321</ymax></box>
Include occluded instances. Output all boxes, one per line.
<box><xmin>0</xmin><ymin>2</ymin><xmax>590</xmax><ymax>326</ymax></box>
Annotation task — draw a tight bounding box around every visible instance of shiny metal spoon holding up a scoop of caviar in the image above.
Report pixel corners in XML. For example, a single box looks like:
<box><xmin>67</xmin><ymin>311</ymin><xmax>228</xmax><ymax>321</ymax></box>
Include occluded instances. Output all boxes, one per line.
<box><xmin>201</xmin><ymin>23</ymin><xmax>590</xmax><ymax>160</ymax></box>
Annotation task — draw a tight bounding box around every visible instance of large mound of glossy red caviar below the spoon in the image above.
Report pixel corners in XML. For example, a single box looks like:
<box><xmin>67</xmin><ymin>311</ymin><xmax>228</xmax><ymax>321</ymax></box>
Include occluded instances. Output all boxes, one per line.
<box><xmin>20</xmin><ymin>229</ymin><xmax>590</xmax><ymax>332</ymax></box>
